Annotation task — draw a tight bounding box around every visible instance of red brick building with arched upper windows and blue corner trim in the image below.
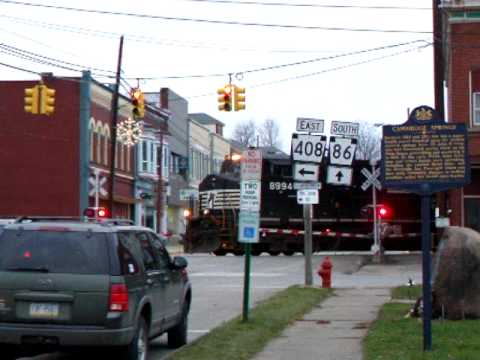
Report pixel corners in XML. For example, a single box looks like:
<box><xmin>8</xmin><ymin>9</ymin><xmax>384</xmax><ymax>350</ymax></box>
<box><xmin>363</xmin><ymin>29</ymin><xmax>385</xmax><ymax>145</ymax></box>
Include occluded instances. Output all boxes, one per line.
<box><xmin>0</xmin><ymin>72</ymin><xmax>168</xmax><ymax>219</ymax></box>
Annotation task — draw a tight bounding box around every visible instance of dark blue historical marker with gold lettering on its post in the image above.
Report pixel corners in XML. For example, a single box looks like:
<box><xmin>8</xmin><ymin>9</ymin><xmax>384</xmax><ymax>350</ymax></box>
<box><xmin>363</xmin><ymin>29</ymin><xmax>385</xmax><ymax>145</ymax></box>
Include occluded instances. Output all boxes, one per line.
<box><xmin>381</xmin><ymin>106</ymin><xmax>470</xmax><ymax>351</ymax></box>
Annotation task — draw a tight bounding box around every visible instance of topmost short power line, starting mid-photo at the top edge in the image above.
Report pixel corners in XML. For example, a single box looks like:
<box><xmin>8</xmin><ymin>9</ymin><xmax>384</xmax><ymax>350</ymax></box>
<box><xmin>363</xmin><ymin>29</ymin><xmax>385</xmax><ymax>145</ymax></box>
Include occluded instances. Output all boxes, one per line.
<box><xmin>184</xmin><ymin>0</ymin><xmax>432</xmax><ymax>11</ymax></box>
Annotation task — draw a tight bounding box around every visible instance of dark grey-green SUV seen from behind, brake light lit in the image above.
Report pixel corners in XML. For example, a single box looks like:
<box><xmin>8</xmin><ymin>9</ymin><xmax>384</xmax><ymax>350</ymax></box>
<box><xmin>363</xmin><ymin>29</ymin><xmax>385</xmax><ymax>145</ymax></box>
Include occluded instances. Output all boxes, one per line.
<box><xmin>0</xmin><ymin>217</ymin><xmax>192</xmax><ymax>360</ymax></box>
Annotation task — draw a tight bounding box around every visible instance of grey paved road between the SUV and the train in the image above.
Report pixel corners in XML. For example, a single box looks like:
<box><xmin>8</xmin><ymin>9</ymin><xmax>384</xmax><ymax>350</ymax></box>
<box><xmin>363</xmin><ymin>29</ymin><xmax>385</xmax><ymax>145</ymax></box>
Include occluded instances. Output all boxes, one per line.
<box><xmin>19</xmin><ymin>255</ymin><xmax>420</xmax><ymax>360</ymax></box>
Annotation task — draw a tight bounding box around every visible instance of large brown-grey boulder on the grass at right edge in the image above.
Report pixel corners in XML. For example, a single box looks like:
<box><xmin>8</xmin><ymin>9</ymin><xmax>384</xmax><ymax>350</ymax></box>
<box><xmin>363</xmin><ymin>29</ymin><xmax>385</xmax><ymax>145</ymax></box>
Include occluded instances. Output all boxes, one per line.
<box><xmin>432</xmin><ymin>226</ymin><xmax>480</xmax><ymax>320</ymax></box>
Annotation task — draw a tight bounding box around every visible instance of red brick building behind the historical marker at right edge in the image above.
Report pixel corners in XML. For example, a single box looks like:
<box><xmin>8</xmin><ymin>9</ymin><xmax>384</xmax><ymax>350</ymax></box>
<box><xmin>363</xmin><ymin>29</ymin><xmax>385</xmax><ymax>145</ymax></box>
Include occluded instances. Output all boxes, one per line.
<box><xmin>438</xmin><ymin>0</ymin><xmax>480</xmax><ymax>231</ymax></box>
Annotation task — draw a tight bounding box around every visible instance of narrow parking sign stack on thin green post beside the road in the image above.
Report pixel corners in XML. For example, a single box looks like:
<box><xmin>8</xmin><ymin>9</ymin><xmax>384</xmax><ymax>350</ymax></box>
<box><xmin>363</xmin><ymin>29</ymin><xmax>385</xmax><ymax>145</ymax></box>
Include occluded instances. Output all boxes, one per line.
<box><xmin>237</xmin><ymin>149</ymin><xmax>262</xmax><ymax>321</ymax></box>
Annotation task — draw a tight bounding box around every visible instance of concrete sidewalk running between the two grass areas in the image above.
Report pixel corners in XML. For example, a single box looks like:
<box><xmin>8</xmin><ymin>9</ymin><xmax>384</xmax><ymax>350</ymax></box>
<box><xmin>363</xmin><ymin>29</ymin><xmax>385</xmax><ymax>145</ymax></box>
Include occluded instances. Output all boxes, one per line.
<box><xmin>253</xmin><ymin>264</ymin><xmax>421</xmax><ymax>360</ymax></box>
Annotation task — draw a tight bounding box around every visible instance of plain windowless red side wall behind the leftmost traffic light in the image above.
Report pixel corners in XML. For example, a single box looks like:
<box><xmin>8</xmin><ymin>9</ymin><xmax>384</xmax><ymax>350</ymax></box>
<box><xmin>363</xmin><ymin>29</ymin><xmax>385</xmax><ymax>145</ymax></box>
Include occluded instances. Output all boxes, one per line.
<box><xmin>0</xmin><ymin>79</ymin><xmax>80</xmax><ymax>216</ymax></box>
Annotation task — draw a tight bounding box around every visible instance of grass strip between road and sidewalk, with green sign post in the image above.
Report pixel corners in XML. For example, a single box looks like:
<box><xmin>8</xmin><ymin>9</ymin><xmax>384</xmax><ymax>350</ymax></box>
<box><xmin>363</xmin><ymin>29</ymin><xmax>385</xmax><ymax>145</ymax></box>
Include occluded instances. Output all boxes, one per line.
<box><xmin>167</xmin><ymin>286</ymin><xmax>332</xmax><ymax>360</ymax></box>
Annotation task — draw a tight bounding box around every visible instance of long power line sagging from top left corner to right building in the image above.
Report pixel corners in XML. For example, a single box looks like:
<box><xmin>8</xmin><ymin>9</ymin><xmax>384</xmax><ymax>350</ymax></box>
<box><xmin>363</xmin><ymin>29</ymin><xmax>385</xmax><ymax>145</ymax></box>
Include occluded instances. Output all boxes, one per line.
<box><xmin>0</xmin><ymin>0</ymin><xmax>432</xmax><ymax>34</ymax></box>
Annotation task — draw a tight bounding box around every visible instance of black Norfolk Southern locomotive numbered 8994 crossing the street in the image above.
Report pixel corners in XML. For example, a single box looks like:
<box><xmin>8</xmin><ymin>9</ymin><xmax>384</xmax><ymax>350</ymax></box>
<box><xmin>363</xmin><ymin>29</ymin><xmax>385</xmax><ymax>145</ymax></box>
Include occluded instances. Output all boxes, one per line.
<box><xmin>185</xmin><ymin>148</ymin><xmax>420</xmax><ymax>255</ymax></box>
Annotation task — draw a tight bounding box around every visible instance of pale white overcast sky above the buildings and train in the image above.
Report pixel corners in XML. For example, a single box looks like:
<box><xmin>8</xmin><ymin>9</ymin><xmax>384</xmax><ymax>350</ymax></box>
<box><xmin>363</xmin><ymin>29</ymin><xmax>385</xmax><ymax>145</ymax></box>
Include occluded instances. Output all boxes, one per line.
<box><xmin>0</xmin><ymin>0</ymin><xmax>433</xmax><ymax>149</ymax></box>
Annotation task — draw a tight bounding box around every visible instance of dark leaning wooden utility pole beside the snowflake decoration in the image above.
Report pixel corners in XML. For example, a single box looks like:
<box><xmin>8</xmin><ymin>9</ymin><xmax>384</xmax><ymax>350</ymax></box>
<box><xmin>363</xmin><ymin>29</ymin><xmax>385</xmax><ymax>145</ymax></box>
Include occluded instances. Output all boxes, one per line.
<box><xmin>108</xmin><ymin>35</ymin><xmax>123</xmax><ymax>218</ymax></box>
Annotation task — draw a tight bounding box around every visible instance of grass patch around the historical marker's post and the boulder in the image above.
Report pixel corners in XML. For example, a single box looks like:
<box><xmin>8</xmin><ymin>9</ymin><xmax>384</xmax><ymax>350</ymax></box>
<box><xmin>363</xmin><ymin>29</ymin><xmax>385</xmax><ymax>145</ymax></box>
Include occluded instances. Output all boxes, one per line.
<box><xmin>364</xmin><ymin>303</ymin><xmax>480</xmax><ymax>360</ymax></box>
